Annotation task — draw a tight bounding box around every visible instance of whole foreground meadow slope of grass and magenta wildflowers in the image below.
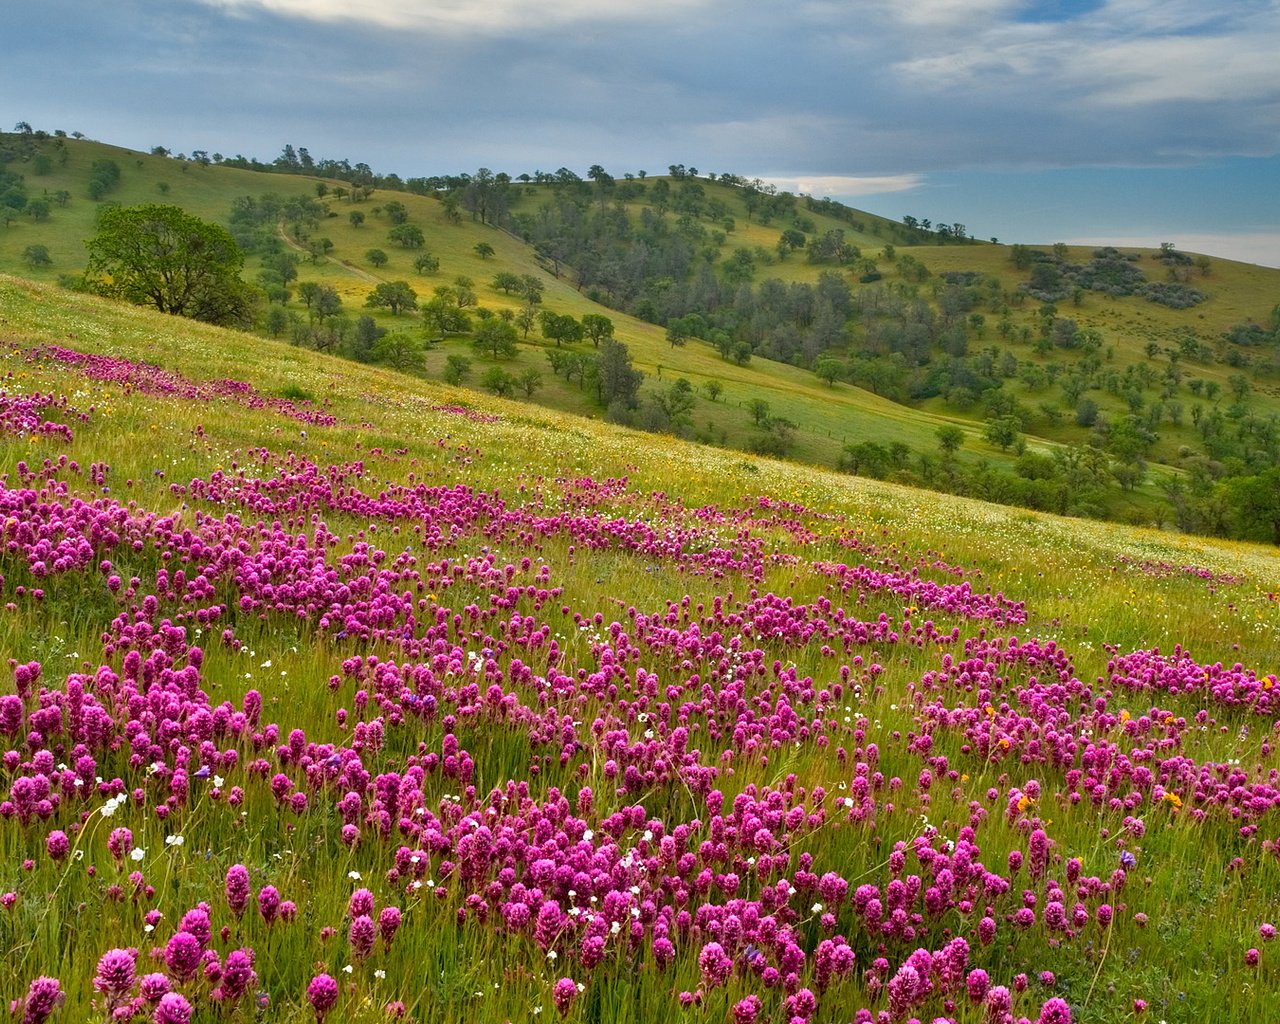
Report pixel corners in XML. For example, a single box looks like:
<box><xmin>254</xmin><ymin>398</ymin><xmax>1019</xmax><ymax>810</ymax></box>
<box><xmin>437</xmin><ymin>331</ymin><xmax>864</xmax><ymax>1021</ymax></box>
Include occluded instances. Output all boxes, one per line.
<box><xmin>0</xmin><ymin>276</ymin><xmax>1280</xmax><ymax>1024</ymax></box>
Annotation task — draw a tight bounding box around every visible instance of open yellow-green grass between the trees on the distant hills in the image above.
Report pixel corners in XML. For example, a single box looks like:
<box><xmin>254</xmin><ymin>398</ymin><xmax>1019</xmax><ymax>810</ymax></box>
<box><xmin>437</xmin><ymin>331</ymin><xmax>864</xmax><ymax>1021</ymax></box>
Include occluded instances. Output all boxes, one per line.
<box><xmin>0</xmin><ymin>140</ymin><xmax>1280</xmax><ymax>521</ymax></box>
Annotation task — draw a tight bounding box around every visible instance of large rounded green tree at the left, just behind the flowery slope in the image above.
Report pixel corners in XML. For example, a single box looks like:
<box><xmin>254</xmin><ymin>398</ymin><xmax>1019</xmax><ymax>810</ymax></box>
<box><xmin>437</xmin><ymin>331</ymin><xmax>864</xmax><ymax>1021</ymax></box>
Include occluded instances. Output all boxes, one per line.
<box><xmin>84</xmin><ymin>204</ymin><xmax>252</xmax><ymax>325</ymax></box>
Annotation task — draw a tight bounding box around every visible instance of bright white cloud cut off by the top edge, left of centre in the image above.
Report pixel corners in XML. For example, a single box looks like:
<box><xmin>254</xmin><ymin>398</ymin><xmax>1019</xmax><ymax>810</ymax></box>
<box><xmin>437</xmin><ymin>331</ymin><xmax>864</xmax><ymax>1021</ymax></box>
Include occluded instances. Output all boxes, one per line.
<box><xmin>201</xmin><ymin>0</ymin><xmax>703</xmax><ymax>36</ymax></box>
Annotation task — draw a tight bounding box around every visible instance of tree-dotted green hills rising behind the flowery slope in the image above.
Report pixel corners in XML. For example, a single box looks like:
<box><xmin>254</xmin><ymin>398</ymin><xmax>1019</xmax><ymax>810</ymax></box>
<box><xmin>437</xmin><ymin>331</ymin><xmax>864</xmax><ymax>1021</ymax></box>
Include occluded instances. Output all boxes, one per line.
<box><xmin>0</xmin><ymin>129</ymin><xmax>1280</xmax><ymax>540</ymax></box>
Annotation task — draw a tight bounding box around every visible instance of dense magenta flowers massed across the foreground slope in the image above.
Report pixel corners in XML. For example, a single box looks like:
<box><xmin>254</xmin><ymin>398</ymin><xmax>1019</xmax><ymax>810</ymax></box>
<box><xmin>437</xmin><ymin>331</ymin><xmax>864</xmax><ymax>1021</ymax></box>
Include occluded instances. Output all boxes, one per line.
<box><xmin>0</xmin><ymin>386</ymin><xmax>1280</xmax><ymax>1024</ymax></box>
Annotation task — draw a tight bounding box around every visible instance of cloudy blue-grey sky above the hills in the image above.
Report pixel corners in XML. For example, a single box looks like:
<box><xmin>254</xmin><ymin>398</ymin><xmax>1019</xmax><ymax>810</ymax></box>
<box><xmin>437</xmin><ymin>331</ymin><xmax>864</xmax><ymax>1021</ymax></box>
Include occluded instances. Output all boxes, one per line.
<box><xmin>0</xmin><ymin>0</ymin><xmax>1280</xmax><ymax>266</ymax></box>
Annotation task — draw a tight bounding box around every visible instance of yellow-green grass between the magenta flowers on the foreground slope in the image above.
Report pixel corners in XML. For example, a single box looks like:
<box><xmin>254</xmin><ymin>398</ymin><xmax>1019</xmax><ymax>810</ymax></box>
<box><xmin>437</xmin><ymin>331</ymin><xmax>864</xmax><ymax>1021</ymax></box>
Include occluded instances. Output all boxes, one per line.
<box><xmin>0</xmin><ymin>273</ymin><xmax>1280</xmax><ymax>1024</ymax></box>
